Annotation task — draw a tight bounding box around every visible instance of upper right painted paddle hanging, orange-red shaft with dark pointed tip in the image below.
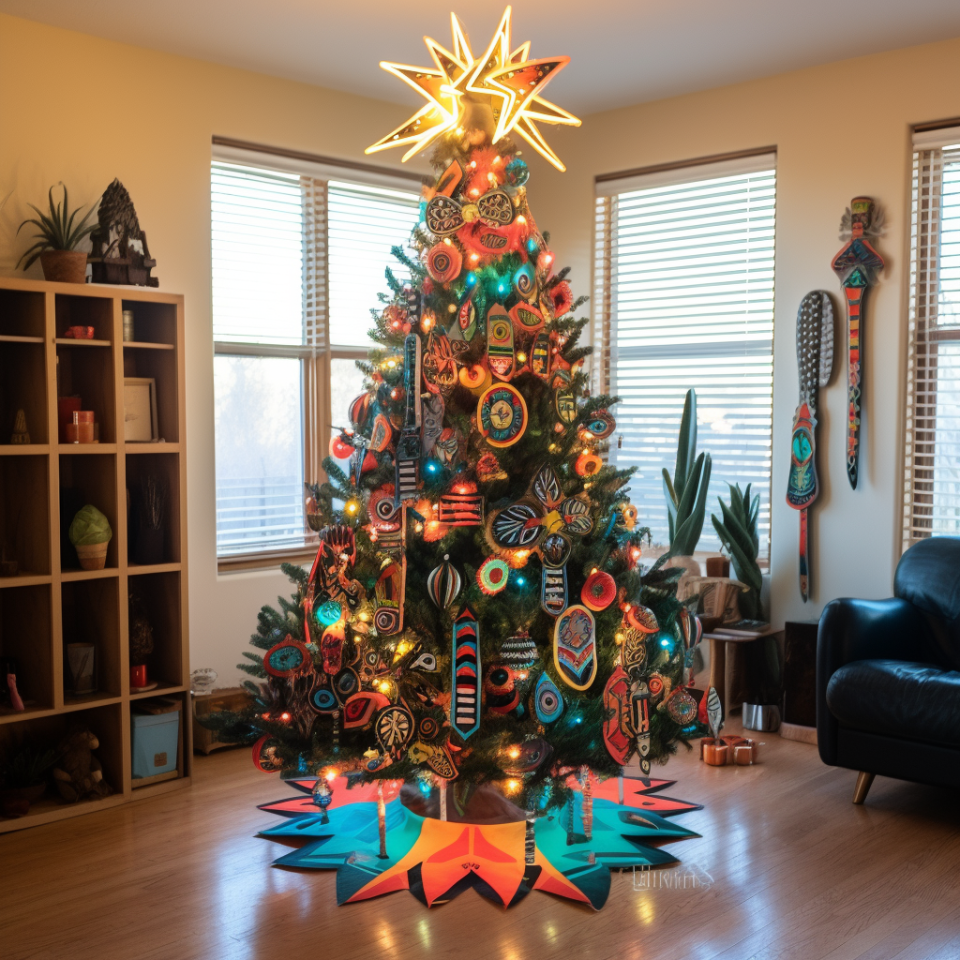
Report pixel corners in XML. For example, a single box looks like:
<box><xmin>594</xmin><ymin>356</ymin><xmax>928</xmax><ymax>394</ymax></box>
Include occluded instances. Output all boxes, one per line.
<box><xmin>831</xmin><ymin>197</ymin><xmax>883</xmax><ymax>490</ymax></box>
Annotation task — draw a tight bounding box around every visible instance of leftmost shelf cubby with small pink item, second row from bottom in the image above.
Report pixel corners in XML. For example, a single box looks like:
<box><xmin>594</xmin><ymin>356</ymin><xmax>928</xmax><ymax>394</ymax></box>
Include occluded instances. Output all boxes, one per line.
<box><xmin>0</xmin><ymin>584</ymin><xmax>54</xmax><ymax>723</ymax></box>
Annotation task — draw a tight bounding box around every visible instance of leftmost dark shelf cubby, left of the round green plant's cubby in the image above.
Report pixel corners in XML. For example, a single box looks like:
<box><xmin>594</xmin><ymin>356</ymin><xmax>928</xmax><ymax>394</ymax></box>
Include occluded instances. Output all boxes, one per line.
<box><xmin>0</xmin><ymin>455</ymin><xmax>50</xmax><ymax>584</ymax></box>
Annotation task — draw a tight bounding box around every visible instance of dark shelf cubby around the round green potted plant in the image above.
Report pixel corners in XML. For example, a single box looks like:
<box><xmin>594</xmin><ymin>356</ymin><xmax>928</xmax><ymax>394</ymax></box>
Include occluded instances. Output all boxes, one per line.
<box><xmin>60</xmin><ymin>447</ymin><xmax>121</xmax><ymax>572</ymax></box>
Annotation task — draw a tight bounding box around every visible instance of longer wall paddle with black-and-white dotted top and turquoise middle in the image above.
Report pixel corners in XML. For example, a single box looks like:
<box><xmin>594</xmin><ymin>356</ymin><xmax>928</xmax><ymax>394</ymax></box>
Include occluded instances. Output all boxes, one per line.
<box><xmin>787</xmin><ymin>290</ymin><xmax>833</xmax><ymax>603</ymax></box>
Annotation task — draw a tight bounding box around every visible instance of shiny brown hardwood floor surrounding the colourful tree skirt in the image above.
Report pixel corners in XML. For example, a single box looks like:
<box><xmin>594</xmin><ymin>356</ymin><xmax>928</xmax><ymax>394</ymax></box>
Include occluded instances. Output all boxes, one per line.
<box><xmin>0</xmin><ymin>723</ymin><xmax>960</xmax><ymax>960</ymax></box>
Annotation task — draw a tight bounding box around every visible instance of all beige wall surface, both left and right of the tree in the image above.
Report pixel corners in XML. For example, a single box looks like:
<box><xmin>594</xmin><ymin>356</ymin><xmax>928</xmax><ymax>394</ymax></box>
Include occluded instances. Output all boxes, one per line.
<box><xmin>0</xmin><ymin>16</ymin><xmax>960</xmax><ymax>680</ymax></box>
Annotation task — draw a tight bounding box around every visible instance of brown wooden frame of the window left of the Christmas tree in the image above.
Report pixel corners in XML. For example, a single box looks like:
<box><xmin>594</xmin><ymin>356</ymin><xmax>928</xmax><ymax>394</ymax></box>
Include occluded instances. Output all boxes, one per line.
<box><xmin>210</xmin><ymin>137</ymin><xmax>426</xmax><ymax>573</ymax></box>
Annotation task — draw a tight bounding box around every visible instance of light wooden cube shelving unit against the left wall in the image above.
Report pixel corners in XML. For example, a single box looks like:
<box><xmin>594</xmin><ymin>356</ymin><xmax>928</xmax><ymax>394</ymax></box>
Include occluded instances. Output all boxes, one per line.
<box><xmin>0</xmin><ymin>278</ymin><xmax>193</xmax><ymax>833</ymax></box>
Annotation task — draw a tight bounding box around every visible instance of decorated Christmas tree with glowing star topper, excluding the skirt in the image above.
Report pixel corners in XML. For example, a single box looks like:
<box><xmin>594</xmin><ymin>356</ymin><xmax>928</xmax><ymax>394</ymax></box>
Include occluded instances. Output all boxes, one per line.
<box><xmin>218</xmin><ymin>3</ymin><xmax>700</xmax><ymax>815</ymax></box>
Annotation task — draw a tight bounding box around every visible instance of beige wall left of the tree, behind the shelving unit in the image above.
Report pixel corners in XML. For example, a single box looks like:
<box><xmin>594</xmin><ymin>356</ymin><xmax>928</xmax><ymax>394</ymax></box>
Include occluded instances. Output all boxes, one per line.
<box><xmin>0</xmin><ymin>15</ymin><xmax>428</xmax><ymax>682</ymax></box>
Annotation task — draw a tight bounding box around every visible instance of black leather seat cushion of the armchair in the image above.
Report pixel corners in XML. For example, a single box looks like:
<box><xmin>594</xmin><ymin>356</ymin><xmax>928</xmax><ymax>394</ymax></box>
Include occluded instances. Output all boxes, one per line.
<box><xmin>826</xmin><ymin>660</ymin><xmax>960</xmax><ymax>748</ymax></box>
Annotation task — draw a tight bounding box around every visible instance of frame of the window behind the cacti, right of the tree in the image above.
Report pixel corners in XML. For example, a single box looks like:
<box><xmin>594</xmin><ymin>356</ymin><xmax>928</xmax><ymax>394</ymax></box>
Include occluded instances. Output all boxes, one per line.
<box><xmin>591</xmin><ymin>146</ymin><xmax>778</xmax><ymax>573</ymax></box>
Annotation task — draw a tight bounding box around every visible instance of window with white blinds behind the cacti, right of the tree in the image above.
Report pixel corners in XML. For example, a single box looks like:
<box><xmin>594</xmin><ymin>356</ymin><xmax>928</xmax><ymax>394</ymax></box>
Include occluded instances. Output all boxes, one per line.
<box><xmin>593</xmin><ymin>153</ymin><xmax>776</xmax><ymax>559</ymax></box>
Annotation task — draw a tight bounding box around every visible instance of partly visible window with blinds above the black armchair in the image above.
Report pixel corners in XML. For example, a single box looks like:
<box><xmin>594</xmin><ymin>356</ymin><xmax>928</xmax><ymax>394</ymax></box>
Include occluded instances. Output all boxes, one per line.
<box><xmin>903</xmin><ymin>127</ymin><xmax>960</xmax><ymax>549</ymax></box>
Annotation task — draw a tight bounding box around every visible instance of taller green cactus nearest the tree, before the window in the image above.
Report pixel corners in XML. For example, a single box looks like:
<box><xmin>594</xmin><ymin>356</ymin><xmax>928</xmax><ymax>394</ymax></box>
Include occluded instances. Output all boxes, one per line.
<box><xmin>663</xmin><ymin>389</ymin><xmax>712</xmax><ymax>557</ymax></box>
